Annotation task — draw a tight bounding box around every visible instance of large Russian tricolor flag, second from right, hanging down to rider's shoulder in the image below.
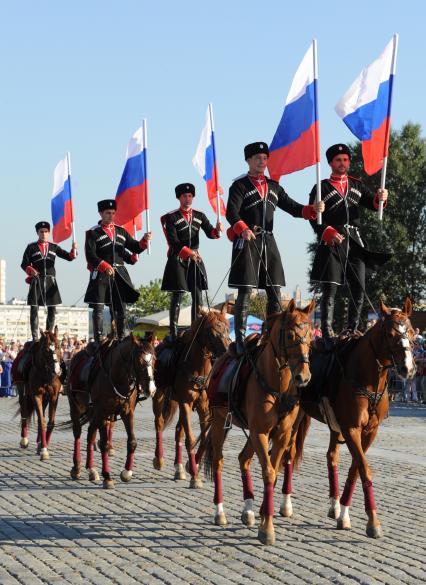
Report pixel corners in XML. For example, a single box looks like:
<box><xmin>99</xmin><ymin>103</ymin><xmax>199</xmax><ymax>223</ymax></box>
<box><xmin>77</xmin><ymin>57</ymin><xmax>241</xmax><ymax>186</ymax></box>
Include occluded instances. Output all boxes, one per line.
<box><xmin>268</xmin><ymin>42</ymin><xmax>320</xmax><ymax>181</ymax></box>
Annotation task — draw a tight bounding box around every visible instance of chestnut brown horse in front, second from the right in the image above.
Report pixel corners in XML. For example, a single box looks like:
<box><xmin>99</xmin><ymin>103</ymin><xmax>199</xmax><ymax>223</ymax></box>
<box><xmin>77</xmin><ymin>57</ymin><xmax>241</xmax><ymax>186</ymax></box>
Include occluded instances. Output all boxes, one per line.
<box><xmin>205</xmin><ymin>300</ymin><xmax>315</xmax><ymax>544</ymax></box>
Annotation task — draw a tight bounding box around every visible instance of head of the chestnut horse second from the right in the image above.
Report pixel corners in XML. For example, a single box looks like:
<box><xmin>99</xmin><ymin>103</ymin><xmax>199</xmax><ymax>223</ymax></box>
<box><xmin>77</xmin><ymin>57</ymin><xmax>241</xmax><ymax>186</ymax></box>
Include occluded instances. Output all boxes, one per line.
<box><xmin>269</xmin><ymin>299</ymin><xmax>315</xmax><ymax>388</ymax></box>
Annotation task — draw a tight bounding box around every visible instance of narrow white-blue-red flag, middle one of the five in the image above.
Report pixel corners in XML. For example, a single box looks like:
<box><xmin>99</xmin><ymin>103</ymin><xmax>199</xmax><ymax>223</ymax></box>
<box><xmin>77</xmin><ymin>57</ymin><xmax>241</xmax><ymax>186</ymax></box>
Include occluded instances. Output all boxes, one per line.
<box><xmin>192</xmin><ymin>105</ymin><xmax>226</xmax><ymax>215</ymax></box>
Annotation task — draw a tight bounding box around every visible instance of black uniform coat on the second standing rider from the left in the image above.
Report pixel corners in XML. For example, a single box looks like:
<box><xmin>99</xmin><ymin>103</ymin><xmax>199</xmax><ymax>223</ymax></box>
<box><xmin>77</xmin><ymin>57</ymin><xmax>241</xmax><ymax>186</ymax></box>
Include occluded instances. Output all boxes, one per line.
<box><xmin>84</xmin><ymin>224</ymin><xmax>142</xmax><ymax>308</ymax></box>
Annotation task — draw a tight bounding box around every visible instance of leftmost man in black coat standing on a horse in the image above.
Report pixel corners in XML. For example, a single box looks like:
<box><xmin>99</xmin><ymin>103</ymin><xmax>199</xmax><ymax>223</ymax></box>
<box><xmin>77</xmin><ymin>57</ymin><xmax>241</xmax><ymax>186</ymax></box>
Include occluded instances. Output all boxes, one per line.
<box><xmin>21</xmin><ymin>221</ymin><xmax>77</xmax><ymax>341</ymax></box>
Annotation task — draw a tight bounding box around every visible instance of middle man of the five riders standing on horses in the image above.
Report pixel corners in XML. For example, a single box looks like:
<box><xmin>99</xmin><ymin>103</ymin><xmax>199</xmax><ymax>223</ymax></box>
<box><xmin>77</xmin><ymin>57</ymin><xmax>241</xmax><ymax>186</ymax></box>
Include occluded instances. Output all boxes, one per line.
<box><xmin>161</xmin><ymin>183</ymin><xmax>223</xmax><ymax>341</ymax></box>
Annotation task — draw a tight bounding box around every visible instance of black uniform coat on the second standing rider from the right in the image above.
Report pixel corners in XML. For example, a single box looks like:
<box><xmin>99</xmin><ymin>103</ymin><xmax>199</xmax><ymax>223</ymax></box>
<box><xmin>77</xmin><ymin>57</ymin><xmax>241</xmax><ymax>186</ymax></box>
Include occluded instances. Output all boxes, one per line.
<box><xmin>226</xmin><ymin>175</ymin><xmax>304</xmax><ymax>288</ymax></box>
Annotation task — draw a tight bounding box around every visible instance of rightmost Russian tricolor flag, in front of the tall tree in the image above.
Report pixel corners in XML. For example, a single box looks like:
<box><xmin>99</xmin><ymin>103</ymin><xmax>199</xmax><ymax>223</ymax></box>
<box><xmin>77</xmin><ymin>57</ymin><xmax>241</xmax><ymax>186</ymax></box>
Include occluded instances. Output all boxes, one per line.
<box><xmin>336</xmin><ymin>35</ymin><xmax>398</xmax><ymax>175</ymax></box>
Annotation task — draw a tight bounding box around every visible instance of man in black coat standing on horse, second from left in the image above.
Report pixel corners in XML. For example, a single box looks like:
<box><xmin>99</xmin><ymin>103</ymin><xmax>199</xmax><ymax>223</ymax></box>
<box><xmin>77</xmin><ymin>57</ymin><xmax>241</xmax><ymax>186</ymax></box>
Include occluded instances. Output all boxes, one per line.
<box><xmin>84</xmin><ymin>199</ymin><xmax>152</xmax><ymax>342</ymax></box>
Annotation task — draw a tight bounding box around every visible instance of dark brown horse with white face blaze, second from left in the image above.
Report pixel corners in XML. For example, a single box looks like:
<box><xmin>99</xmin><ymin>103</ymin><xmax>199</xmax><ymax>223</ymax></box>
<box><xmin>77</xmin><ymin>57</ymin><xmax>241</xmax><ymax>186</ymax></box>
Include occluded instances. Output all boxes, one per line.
<box><xmin>67</xmin><ymin>334</ymin><xmax>156</xmax><ymax>489</ymax></box>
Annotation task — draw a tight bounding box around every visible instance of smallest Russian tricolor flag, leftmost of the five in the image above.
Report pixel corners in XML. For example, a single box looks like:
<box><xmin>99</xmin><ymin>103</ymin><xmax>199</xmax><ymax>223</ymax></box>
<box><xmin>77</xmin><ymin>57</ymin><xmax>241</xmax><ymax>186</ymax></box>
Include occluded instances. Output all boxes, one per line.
<box><xmin>51</xmin><ymin>155</ymin><xmax>74</xmax><ymax>244</ymax></box>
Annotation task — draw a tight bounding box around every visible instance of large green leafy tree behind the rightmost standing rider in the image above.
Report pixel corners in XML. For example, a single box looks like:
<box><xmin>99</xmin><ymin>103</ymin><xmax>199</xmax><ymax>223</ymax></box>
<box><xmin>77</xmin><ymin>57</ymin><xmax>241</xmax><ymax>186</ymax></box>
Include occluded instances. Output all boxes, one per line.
<box><xmin>308</xmin><ymin>122</ymin><xmax>426</xmax><ymax>328</ymax></box>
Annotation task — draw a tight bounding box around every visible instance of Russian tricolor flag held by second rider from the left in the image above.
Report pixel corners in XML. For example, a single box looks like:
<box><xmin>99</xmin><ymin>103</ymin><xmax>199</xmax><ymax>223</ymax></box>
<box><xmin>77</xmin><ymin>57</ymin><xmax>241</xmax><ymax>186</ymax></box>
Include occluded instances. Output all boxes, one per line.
<box><xmin>115</xmin><ymin>126</ymin><xmax>148</xmax><ymax>228</ymax></box>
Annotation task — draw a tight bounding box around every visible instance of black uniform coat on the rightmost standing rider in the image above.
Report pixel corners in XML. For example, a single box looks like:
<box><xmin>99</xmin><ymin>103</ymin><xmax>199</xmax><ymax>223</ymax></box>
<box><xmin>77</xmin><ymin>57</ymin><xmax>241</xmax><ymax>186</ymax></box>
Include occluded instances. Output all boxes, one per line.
<box><xmin>309</xmin><ymin>177</ymin><xmax>391</xmax><ymax>285</ymax></box>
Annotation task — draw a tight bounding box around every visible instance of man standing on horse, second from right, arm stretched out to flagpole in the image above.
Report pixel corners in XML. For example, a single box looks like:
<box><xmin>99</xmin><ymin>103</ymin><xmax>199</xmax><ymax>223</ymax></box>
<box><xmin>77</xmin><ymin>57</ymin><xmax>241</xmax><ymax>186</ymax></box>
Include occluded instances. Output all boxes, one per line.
<box><xmin>226</xmin><ymin>142</ymin><xmax>323</xmax><ymax>353</ymax></box>
